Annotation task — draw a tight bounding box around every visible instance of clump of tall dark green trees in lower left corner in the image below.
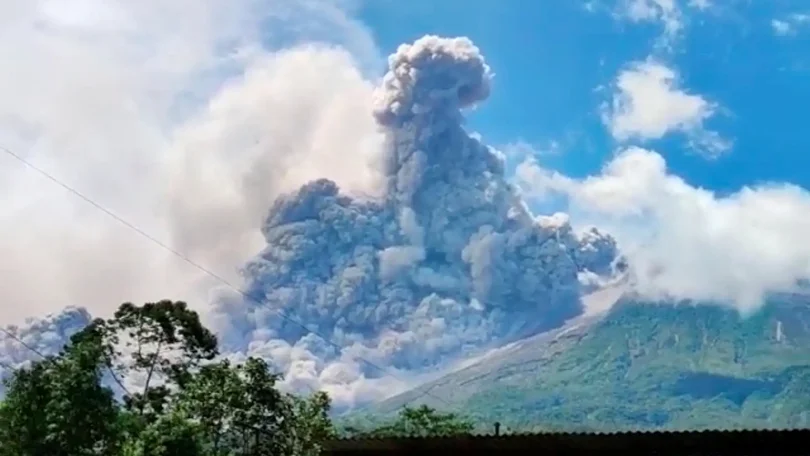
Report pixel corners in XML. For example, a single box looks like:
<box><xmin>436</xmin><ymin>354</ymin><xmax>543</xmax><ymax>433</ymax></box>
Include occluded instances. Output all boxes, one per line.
<box><xmin>0</xmin><ymin>301</ymin><xmax>334</xmax><ymax>456</ymax></box>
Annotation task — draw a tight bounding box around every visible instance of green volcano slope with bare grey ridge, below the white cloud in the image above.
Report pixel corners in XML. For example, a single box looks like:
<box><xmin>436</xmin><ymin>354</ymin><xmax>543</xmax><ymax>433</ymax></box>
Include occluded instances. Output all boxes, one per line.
<box><xmin>364</xmin><ymin>295</ymin><xmax>810</xmax><ymax>431</ymax></box>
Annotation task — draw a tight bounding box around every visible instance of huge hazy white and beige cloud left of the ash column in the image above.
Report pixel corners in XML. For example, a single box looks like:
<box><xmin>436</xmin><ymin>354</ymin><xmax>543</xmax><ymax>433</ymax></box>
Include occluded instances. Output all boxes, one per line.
<box><xmin>0</xmin><ymin>0</ymin><xmax>379</xmax><ymax>323</ymax></box>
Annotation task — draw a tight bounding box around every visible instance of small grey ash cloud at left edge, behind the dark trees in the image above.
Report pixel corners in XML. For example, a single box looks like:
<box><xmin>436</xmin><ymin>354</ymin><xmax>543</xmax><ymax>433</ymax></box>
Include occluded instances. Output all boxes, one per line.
<box><xmin>0</xmin><ymin>307</ymin><xmax>92</xmax><ymax>392</ymax></box>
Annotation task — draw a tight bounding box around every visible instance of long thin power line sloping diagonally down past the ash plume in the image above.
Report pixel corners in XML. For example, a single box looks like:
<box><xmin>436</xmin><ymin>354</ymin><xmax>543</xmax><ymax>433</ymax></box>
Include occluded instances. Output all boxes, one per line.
<box><xmin>0</xmin><ymin>145</ymin><xmax>452</xmax><ymax>407</ymax></box>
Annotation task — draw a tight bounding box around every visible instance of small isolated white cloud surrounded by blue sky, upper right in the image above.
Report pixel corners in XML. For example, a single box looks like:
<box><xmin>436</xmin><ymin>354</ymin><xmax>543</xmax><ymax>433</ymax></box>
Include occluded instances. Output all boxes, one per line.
<box><xmin>602</xmin><ymin>59</ymin><xmax>730</xmax><ymax>156</ymax></box>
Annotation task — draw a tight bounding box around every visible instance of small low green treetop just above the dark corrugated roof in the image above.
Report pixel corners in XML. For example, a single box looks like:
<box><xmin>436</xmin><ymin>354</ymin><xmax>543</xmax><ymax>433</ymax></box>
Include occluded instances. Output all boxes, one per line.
<box><xmin>361</xmin><ymin>405</ymin><xmax>475</xmax><ymax>438</ymax></box>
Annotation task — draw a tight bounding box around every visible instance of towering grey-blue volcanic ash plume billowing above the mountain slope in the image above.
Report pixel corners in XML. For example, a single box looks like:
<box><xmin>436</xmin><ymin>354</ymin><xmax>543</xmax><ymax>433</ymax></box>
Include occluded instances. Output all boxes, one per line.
<box><xmin>208</xmin><ymin>36</ymin><xmax>617</xmax><ymax>405</ymax></box>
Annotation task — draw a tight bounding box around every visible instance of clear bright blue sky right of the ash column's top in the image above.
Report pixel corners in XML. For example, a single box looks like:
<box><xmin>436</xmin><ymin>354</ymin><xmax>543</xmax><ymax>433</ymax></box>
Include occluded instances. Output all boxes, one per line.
<box><xmin>360</xmin><ymin>0</ymin><xmax>810</xmax><ymax>194</ymax></box>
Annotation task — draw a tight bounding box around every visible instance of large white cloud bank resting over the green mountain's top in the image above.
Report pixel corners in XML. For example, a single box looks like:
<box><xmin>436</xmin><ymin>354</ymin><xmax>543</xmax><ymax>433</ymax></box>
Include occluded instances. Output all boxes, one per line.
<box><xmin>517</xmin><ymin>147</ymin><xmax>810</xmax><ymax>312</ymax></box>
